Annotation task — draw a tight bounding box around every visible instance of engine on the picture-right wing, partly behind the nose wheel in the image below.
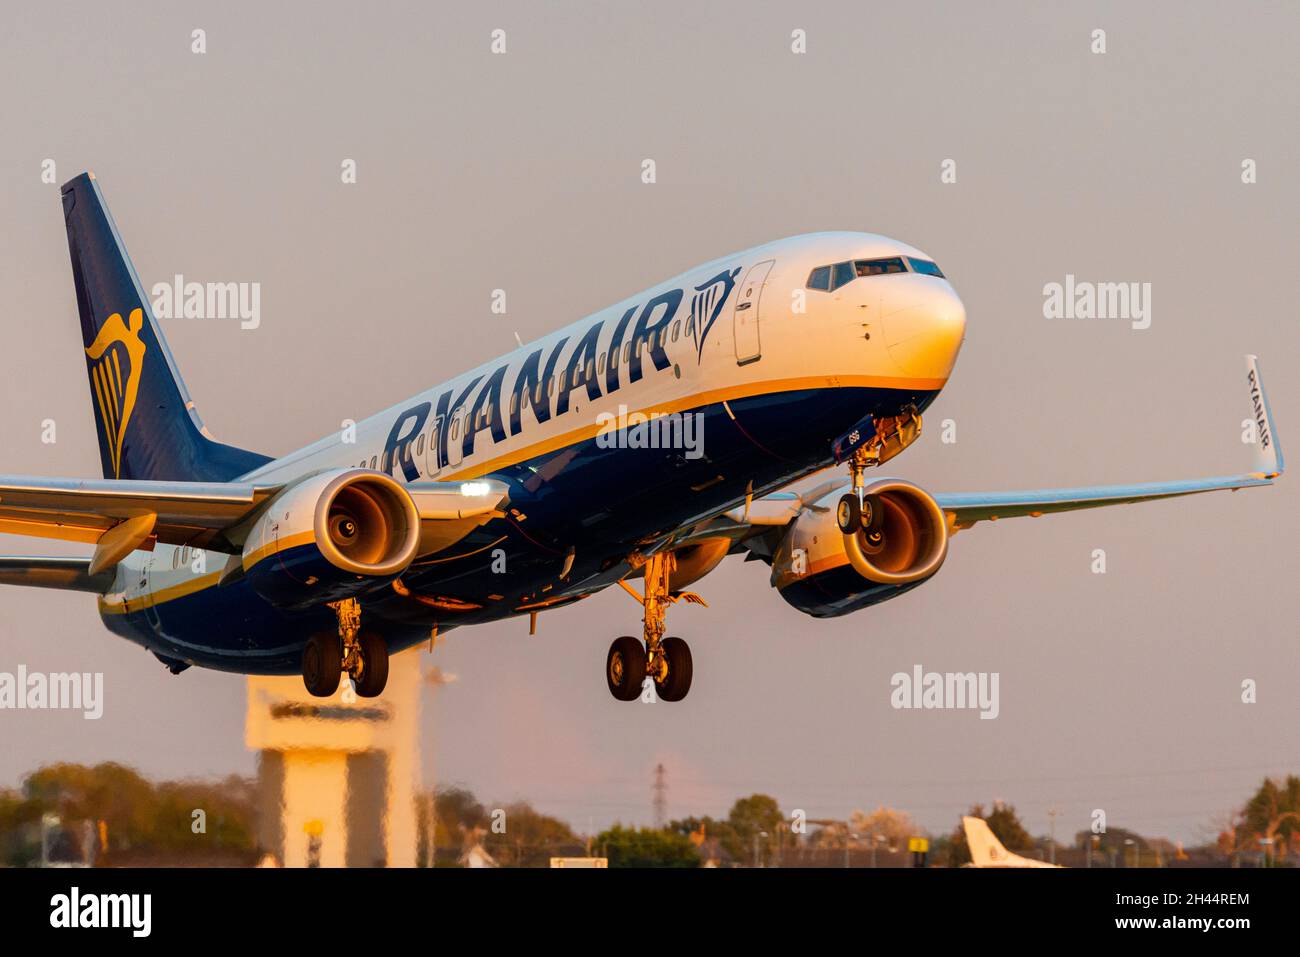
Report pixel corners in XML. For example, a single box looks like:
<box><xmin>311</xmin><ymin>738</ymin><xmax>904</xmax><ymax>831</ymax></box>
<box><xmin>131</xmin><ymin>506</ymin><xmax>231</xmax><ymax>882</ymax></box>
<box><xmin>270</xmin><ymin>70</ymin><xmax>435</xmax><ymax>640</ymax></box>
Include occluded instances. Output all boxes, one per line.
<box><xmin>772</xmin><ymin>479</ymin><xmax>948</xmax><ymax>618</ymax></box>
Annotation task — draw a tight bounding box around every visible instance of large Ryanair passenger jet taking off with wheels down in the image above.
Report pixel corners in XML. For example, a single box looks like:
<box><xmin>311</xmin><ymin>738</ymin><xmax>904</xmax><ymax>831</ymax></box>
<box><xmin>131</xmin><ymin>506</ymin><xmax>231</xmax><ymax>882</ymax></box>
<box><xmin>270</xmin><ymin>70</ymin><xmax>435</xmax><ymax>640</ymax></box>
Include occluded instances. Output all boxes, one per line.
<box><xmin>0</xmin><ymin>173</ymin><xmax>1283</xmax><ymax>701</ymax></box>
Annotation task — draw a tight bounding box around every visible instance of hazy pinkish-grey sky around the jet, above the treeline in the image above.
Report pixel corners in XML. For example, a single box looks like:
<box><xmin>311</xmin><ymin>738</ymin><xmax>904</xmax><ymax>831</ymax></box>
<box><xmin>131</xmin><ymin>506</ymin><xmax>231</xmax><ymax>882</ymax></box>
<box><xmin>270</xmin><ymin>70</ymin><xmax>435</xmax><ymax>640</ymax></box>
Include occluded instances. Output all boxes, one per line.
<box><xmin>0</xmin><ymin>3</ymin><xmax>1300</xmax><ymax>839</ymax></box>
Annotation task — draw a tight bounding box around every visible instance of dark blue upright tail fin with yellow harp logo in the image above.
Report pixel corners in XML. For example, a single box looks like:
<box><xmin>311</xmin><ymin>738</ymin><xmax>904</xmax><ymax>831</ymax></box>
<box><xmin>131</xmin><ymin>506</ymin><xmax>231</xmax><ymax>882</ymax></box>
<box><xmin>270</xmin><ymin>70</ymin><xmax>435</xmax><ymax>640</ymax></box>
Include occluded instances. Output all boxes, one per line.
<box><xmin>62</xmin><ymin>173</ymin><xmax>270</xmax><ymax>481</ymax></box>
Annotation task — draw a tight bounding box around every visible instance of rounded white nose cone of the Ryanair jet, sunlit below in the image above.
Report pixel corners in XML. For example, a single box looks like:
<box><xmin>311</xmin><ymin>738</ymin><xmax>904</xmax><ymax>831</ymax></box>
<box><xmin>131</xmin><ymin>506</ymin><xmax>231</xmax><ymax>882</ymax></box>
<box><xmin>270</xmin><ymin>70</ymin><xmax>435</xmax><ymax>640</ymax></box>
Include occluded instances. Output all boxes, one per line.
<box><xmin>884</xmin><ymin>276</ymin><xmax>966</xmax><ymax>380</ymax></box>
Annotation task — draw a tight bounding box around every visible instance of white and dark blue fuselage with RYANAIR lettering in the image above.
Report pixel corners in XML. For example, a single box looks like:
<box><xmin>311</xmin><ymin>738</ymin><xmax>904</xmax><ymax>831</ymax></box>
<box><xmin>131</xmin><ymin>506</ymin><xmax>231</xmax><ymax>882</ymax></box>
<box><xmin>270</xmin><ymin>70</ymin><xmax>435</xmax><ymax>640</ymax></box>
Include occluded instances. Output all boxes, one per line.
<box><xmin>100</xmin><ymin>233</ymin><xmax>966</xmax><ymax>674</ymax></box>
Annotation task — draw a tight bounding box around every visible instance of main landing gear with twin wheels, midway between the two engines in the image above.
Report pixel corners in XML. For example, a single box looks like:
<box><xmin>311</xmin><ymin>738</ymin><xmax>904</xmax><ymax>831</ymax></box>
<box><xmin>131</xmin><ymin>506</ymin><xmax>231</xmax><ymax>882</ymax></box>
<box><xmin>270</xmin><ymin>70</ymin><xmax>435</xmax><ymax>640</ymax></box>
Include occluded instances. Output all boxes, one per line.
<box><xmin>605</xmin><ymin>553</ymin><xmax>707</xmax><ymax>701</ymax></box>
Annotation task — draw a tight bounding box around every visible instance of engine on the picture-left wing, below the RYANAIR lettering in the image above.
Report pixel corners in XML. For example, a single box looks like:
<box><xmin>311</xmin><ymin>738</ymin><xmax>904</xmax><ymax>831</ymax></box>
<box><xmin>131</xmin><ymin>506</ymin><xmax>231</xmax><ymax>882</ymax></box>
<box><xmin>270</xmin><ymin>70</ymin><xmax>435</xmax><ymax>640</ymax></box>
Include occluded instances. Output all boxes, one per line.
<box><xmin>243</xmin><ymin>468</ymin><xmax>420</xmax><ymax>609</ymax></box>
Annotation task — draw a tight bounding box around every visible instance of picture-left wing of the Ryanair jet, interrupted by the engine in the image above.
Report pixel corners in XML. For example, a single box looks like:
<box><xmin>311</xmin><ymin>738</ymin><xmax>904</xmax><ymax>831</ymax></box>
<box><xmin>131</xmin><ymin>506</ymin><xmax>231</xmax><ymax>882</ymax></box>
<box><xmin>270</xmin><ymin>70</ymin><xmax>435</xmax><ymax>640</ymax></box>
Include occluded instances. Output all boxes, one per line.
<box><xmin>0</xmin><ymin>476</ymin><xmax>508</xmax><ymax>579</ymax></box>
